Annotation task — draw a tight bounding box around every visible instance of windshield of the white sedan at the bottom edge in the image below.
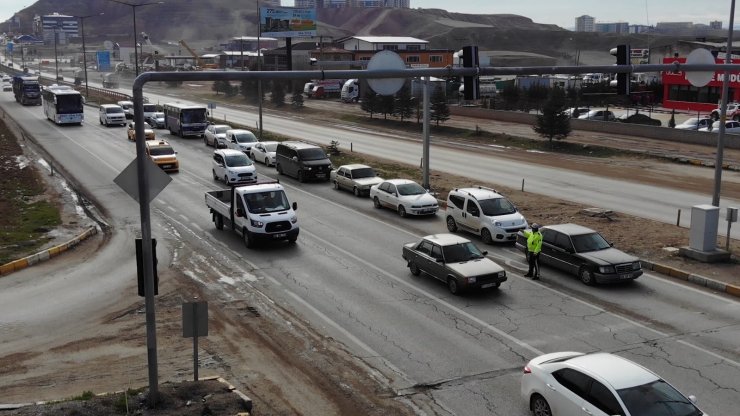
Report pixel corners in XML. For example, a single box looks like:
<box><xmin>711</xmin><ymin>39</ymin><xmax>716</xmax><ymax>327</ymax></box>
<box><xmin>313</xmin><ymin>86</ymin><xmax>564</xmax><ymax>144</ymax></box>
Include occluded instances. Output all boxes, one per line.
<box><xmin>617</xmin><ymin>380</ymin><xmax>702</xmax><ymax>416</ymax></box>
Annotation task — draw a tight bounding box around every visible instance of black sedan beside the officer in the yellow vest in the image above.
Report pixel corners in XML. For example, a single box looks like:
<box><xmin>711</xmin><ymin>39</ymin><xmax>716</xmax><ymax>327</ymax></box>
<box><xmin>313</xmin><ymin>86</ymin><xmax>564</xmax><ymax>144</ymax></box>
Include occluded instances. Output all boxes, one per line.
<box><xmin>516</xmin><ymin>224</ymin><xmax>642</xmax><ymax>285</ymax></box>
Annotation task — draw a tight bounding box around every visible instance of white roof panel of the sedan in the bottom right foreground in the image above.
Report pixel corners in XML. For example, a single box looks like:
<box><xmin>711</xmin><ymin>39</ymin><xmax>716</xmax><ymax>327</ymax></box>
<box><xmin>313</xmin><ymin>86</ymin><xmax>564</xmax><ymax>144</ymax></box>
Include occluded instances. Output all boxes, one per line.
<box><xmin>565</xmin><ymin>352</ymin><xmax>660</xmax><ymax>390</ymax></box>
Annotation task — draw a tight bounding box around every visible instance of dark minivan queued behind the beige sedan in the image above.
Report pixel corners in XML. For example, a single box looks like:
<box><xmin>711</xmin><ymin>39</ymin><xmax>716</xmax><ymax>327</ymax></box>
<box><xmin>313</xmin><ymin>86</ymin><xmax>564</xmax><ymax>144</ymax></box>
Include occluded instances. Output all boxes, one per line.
<box><xmin>275</xmin><ymin>141</ymin><xmax>332</xmax><ymax>182</ymax></box>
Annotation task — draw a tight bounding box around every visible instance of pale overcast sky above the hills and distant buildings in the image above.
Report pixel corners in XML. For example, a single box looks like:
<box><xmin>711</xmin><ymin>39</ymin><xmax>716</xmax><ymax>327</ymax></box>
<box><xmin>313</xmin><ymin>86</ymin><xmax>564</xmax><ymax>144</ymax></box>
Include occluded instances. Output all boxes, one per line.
<box><xmin>0</xmin><ymin>0</ymin><xmax>740</xmax><ymax>31</ymax></box>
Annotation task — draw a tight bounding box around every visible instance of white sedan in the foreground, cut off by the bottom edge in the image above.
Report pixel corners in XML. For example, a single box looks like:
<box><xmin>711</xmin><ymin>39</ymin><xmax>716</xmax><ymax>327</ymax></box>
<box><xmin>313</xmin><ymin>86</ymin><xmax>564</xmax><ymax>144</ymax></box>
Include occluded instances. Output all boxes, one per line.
<box><xmin>521</xmin><ymin>352</ymin><xmax>706</xmax><ymax>416</ymax></box>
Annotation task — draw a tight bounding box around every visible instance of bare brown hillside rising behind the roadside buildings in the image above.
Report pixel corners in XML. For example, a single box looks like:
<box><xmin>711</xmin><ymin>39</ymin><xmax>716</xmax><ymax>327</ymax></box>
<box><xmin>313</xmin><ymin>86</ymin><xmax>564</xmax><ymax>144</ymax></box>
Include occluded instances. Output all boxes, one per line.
<box><xmin>0</xmin><ymin>0</ymin><xmax>688</xmax><ymax>66</ymax></box>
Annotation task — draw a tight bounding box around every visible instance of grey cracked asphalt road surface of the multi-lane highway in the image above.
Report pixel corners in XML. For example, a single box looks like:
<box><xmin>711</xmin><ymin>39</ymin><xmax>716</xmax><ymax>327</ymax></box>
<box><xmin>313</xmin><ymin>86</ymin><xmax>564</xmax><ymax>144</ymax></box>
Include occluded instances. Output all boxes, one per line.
<box><xmin>0</xmin><ymin>85</ymin><xmax>740</xmax><ymax>416</ymax></box>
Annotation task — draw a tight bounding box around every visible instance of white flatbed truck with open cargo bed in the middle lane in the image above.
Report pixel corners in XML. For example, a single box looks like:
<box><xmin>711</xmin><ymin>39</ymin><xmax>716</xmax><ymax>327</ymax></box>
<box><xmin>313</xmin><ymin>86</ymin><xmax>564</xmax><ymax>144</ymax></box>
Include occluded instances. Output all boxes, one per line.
<box><xmin>205</xmin><ymin>181</ymin><xmax>299</xmax><ymax>248</ymax></box>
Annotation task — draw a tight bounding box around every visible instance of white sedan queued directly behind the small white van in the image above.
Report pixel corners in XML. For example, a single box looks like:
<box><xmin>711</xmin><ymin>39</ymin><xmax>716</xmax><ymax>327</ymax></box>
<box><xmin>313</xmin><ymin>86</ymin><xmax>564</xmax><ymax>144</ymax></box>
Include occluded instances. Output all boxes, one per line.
<box><xmin>370</xmin><ymin>179</ymin><xmax>439</xmax><ymax>217</ymax></box>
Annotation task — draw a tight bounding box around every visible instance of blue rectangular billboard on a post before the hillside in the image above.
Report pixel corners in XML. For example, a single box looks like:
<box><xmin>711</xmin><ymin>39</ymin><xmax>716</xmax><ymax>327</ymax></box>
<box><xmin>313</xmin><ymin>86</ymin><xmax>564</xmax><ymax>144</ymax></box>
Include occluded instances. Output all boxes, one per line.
<box><xmin>260</xmin><ymin>7</ymin><xmax>316</xmax><ymax>38</ymax></box>
